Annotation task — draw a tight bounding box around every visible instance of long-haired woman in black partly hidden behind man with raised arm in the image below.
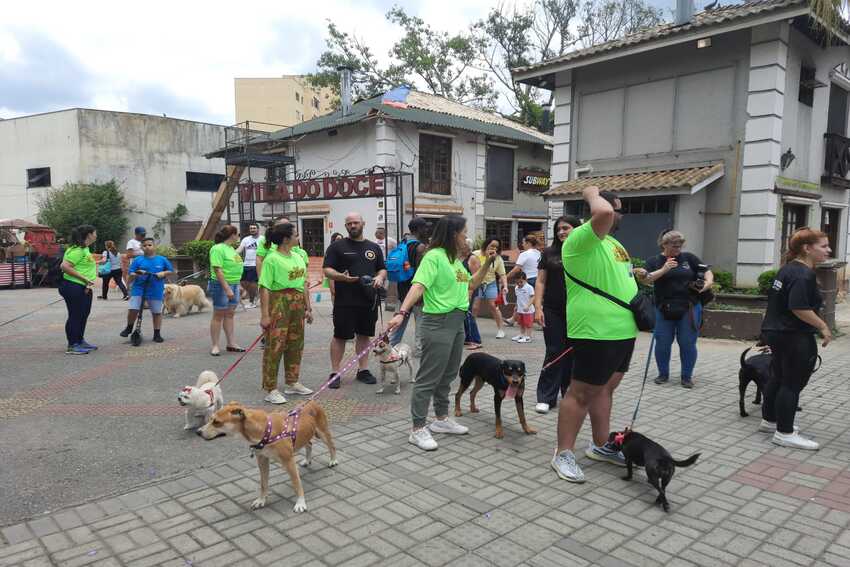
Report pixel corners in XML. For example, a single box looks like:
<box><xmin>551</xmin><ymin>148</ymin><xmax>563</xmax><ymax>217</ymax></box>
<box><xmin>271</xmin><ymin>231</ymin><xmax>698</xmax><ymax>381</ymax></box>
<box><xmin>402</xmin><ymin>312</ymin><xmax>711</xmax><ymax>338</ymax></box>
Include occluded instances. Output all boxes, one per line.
<box><xmin>534</xmin><ymin>215</ymin><xmax>581</xmax><ymax>413</ymax></box>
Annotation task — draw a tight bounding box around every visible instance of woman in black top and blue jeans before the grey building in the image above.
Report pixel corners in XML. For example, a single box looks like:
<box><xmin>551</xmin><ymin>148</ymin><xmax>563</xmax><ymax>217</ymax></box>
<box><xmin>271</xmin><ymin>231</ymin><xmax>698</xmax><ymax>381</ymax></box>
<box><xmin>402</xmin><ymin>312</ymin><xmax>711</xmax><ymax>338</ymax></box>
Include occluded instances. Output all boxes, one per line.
<box><xmin>635</xmin><ymin>230</ymin><xmax>714</xmax><ymax>388</ymax></box>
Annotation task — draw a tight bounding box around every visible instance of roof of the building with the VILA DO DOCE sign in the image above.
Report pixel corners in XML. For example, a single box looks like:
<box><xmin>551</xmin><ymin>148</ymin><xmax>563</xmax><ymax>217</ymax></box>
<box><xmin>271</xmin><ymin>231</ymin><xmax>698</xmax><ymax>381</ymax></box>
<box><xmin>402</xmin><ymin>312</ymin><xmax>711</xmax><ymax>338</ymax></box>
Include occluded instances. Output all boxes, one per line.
<box><xmin>271</xmin><ymin>91</ymin><xmax>554</xmax><ymax>145</ymax></box>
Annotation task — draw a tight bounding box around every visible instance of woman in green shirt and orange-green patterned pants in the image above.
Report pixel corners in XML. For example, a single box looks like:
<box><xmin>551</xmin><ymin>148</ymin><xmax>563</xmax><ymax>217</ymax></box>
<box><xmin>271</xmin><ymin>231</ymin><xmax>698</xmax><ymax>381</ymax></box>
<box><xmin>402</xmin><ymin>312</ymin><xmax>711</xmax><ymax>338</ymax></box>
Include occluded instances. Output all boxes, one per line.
<box><xmin>260</xmin><ymin>224</ymin><xmax>313</xmax><ymax>404</ymax></box>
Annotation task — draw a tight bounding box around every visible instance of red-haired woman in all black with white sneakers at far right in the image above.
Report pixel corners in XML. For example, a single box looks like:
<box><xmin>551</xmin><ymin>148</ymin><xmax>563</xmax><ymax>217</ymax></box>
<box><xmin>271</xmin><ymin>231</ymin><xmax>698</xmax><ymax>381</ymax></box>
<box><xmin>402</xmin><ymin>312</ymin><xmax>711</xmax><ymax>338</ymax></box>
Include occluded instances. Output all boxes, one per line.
<box><xmin>759</xmin><ymin>228</ymin><xmax>832</xmax><ymax>451</ymax></box>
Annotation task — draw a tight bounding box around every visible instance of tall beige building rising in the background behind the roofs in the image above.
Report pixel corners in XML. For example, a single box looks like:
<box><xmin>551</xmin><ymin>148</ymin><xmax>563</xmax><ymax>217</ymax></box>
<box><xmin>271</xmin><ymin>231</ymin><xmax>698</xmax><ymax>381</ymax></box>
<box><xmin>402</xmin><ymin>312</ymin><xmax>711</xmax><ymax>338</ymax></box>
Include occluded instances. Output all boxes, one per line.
<box><xmin>235</xmin><ymin>75</ymin><xmax>334</xmax><ymax>131</ymax></box>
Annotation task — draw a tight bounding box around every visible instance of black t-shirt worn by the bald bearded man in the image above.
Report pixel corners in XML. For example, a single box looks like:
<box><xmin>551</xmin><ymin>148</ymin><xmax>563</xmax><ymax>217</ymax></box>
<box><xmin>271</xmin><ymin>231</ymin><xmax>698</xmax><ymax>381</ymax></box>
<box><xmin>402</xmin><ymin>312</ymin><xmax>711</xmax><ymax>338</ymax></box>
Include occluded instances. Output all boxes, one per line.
<box><xmin>322</xmin><ymin>238</ymin><xmax>386</xmax><ymax>307</ymax></box>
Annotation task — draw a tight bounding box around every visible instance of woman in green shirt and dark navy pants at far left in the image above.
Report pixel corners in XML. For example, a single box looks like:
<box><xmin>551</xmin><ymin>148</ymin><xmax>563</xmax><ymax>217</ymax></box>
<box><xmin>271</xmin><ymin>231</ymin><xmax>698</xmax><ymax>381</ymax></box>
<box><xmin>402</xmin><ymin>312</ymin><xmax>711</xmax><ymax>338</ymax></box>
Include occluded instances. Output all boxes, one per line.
<box><xmin>59</xmin><ymin>224</ymin><xmax>97</xmax><ymax>354</ymax></box>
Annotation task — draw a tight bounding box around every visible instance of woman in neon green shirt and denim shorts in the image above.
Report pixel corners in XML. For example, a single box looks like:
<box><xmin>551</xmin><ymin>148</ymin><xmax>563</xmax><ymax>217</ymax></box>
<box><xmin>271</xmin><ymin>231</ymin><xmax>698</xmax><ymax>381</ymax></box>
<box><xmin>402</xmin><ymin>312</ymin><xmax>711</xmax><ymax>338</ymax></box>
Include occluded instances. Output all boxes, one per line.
<box><xmin>208</xmin><ymin>225</ymin><xmax>245</xmax><ymax>356</ymax></box>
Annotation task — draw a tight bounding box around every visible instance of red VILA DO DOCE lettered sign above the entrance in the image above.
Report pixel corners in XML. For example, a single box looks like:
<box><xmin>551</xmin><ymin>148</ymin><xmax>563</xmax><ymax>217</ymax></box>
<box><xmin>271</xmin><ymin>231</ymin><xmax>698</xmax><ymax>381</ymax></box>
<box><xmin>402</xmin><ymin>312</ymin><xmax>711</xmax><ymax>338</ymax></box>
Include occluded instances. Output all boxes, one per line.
<box><xmin>239</xmin><ymin>174</ymin><xmax>384</xmax><ymax>203</ymax></box>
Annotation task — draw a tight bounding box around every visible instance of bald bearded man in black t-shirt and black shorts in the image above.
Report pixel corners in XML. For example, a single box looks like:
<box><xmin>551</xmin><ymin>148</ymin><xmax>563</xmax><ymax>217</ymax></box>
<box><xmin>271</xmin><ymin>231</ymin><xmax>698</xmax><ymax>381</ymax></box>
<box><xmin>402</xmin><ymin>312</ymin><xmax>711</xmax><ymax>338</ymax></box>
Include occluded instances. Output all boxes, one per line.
<box><xmin>322</xmin><ymin>213</ymin><xmax>387</xmax><ymax>388</ymax></box>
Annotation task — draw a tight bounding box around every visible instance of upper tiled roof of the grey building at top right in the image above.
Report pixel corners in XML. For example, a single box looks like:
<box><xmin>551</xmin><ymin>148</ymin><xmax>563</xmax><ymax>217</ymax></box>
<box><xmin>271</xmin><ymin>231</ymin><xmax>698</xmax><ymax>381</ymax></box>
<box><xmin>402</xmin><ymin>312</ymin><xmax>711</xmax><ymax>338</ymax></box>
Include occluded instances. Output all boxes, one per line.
<box><xmin>512</xmin><ymin>0</ymin><xmax>808</xmax><ymax>79</ymax></box>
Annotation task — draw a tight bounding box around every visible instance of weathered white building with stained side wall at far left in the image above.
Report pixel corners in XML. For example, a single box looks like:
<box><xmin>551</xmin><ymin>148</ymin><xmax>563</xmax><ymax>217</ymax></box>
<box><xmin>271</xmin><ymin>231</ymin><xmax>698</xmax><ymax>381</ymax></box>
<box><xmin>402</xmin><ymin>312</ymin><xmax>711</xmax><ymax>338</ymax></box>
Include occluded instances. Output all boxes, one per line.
<box><xmin>0</xmin><ymin>108</ymin><xmax>224</xmax><ymax>246</ymax></box>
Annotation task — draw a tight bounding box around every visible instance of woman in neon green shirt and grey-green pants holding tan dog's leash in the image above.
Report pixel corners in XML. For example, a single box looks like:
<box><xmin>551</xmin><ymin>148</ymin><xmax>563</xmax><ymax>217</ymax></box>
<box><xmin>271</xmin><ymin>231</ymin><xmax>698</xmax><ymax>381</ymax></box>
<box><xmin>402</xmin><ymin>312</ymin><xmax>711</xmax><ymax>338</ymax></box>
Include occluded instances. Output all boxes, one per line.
<box><xmin>387</xmin><ymin>215</ymin><xmax>496</xmax><ymax>451</ymax></box>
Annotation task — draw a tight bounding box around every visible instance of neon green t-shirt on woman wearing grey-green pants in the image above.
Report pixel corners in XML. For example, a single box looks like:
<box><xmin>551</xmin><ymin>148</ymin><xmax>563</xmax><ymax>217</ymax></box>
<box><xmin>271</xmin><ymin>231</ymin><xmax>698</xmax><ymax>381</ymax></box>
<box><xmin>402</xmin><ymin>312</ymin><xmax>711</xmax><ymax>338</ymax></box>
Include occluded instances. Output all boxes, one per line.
<box><xmin>412</xmin><ymin>248</ymin><xmax>471</xmax><ymax>315</ymax></box>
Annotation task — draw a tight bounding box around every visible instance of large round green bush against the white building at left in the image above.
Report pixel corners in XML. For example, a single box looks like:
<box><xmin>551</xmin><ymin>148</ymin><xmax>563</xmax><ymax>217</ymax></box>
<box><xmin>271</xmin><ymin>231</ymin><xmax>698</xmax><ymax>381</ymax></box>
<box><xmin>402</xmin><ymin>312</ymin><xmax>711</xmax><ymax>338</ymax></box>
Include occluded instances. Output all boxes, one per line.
<box><xmin>38</xmin><ymin>179</ymin><xmax>130</xmax><ymax>250</ymax></box>
